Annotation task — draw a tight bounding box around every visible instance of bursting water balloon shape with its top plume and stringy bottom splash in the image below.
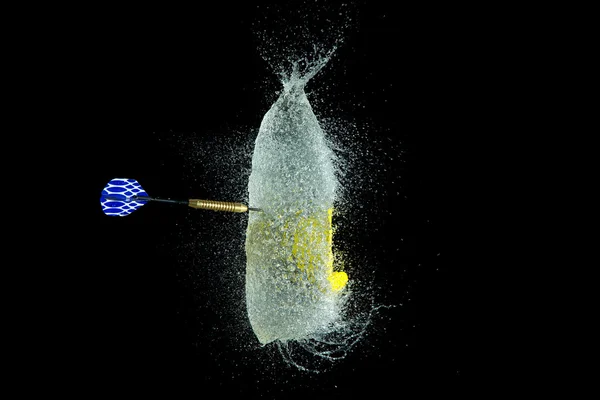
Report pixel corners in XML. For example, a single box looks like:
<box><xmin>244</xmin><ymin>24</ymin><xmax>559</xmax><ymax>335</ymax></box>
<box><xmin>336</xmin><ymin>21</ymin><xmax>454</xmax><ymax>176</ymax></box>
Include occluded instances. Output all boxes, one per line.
<box><xmin>246</xmin><ymin>6</ymin><xmax>378</xmax><ymax>372</ymax></box>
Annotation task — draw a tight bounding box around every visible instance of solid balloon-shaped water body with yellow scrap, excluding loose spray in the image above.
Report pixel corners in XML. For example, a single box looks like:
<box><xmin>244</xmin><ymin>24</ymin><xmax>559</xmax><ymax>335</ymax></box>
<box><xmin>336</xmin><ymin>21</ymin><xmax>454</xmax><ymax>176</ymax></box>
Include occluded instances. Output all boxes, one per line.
<box><xmin>246</xmin><ymin>64</ymin><xmax>347</xmax><ymax>344</ymax></box>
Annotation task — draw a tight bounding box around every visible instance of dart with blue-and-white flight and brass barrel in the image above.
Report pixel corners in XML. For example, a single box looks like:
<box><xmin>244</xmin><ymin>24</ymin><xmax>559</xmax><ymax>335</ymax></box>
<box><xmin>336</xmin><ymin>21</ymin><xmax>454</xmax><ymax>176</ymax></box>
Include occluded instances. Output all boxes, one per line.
<box><xmin>100</xmin><ymin>178</ymin><xmax>261</xmax><ymax>217</ymax></box>
